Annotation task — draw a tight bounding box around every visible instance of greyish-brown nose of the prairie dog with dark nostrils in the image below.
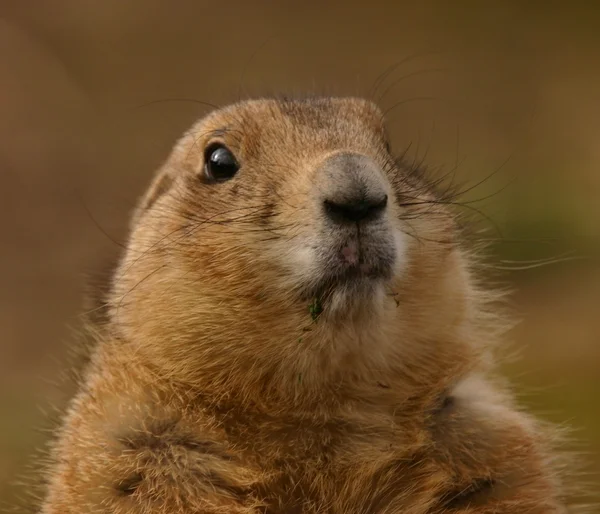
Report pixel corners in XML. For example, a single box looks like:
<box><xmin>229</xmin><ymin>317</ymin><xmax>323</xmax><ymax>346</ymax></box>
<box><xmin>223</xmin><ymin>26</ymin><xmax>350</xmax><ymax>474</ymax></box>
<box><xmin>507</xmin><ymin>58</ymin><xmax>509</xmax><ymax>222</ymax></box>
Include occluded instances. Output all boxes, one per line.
<box><xmin>317</xmin><ymin>153</ymin><xmax>388</xmax><ymax>223</ymax></box>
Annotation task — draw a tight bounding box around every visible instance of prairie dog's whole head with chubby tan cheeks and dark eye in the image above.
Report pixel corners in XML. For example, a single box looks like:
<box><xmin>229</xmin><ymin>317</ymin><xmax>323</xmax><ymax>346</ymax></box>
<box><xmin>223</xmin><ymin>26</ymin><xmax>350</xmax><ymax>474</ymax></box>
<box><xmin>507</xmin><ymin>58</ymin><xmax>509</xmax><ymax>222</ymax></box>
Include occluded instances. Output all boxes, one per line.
<box><xmin>111</xmin><ymin>98</ymin><xmax>482</xmax><ymax>398</ymax></box>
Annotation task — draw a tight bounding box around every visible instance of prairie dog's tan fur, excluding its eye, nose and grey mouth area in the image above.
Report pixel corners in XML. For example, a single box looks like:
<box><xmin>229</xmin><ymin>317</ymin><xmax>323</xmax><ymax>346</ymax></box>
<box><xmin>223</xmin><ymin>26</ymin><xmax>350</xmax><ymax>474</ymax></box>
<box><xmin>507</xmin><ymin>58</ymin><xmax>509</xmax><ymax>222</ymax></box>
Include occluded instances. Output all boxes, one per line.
<box><xmin>42</xmin><ymin>99</ymin><xmax>565</xmax><ymax>514</ymax></box>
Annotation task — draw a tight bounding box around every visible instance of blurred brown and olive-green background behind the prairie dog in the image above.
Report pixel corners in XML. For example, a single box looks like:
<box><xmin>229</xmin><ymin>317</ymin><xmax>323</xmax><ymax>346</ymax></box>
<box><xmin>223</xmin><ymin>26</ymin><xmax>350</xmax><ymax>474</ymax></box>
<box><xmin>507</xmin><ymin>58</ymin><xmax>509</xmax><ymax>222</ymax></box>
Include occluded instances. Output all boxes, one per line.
<box><xmin>0</xmin><ymin>0</ymin><xmax>600</xmax><ymax>503</ymax></box>
